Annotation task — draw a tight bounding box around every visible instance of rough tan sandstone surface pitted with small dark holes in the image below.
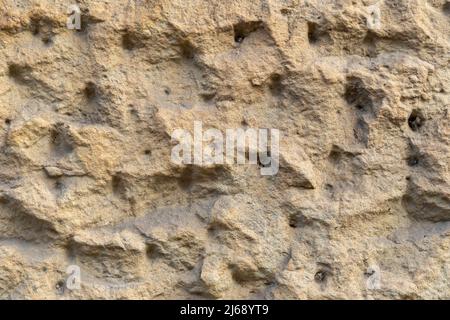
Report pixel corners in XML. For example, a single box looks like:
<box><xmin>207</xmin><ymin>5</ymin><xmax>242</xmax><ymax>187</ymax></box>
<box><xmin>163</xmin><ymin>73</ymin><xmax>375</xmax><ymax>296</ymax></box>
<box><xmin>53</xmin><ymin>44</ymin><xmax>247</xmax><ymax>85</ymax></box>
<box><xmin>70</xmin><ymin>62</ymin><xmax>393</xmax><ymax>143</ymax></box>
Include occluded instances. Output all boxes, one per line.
<box><xmin>0</xmin><ymin>0</ymin><xmax>450</xmax><ymax>299</ymax></box>
